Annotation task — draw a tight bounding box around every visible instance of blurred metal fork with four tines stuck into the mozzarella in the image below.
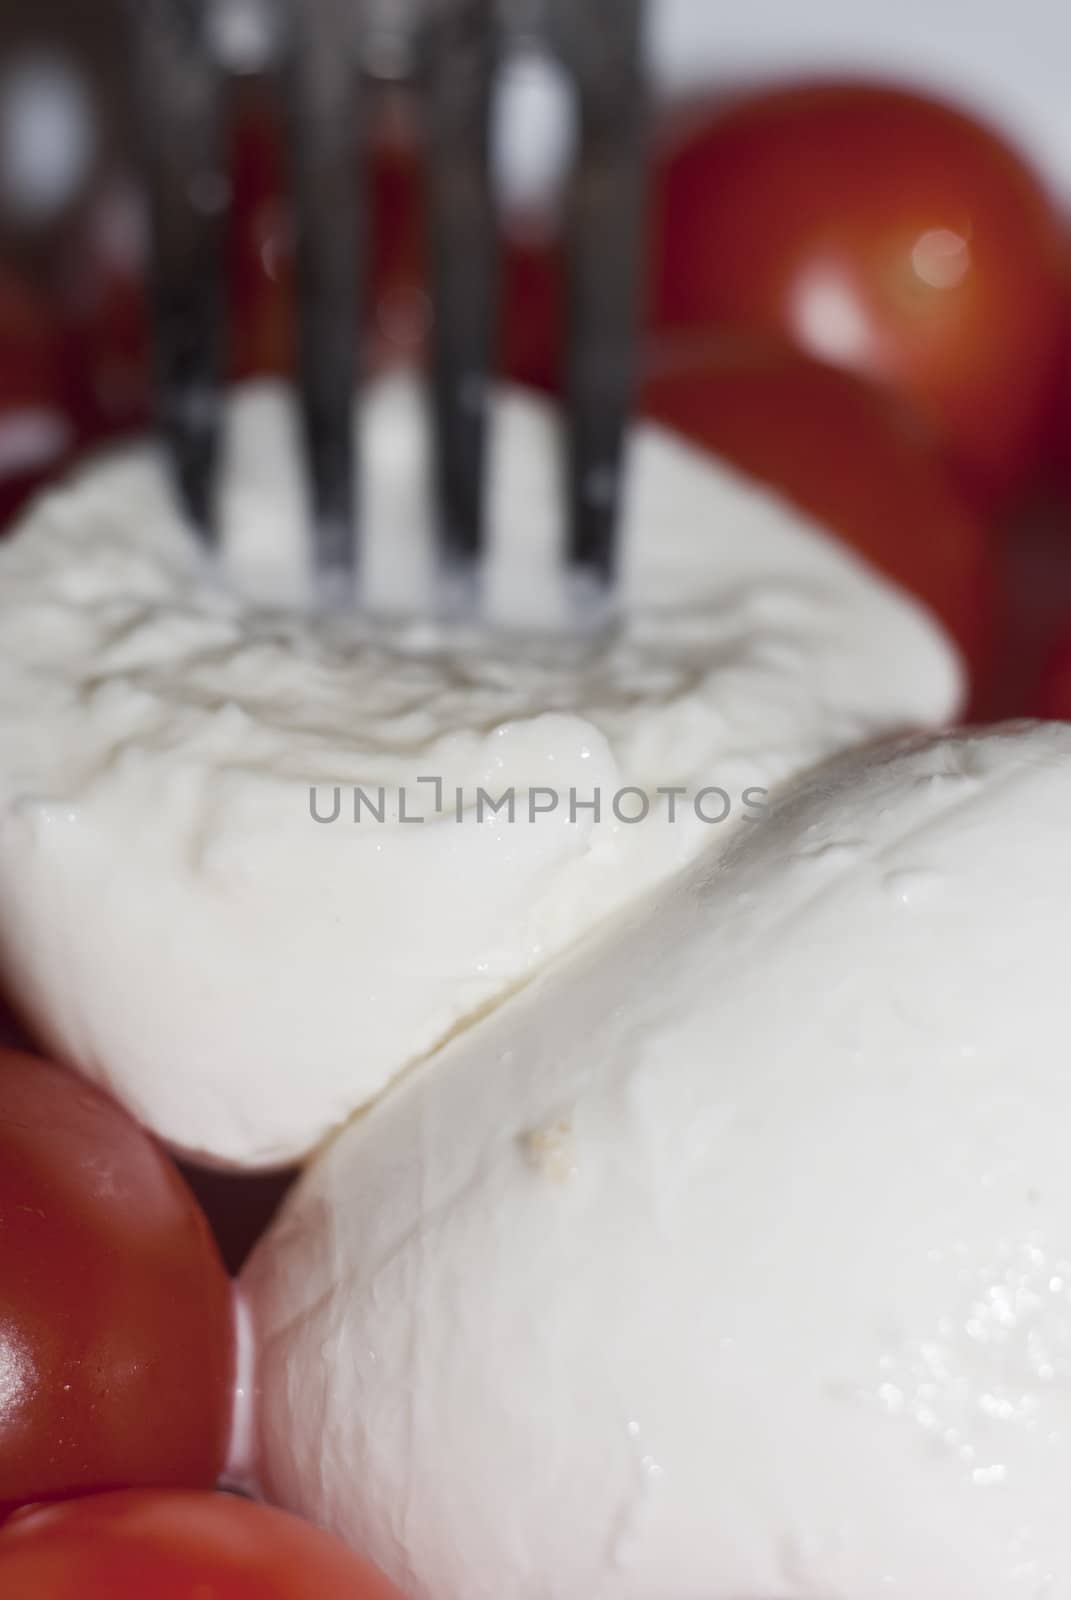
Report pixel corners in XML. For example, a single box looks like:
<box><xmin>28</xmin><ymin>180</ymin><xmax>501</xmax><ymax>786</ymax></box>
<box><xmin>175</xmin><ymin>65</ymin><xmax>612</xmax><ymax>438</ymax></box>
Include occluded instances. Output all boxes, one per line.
<box><xmin>133</xmin><ymin>0</ymin><xmax>645</xmax><ymax>592</ymax></box>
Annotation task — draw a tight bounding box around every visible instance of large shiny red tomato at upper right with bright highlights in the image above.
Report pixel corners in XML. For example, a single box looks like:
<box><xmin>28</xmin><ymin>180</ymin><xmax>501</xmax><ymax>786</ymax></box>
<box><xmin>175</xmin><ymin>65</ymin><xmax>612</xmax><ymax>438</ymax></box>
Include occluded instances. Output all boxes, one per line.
<box><xmin>653</xmin><ymin>83</ymin><xmax>1065</xmax><ymax>498</ymax></box>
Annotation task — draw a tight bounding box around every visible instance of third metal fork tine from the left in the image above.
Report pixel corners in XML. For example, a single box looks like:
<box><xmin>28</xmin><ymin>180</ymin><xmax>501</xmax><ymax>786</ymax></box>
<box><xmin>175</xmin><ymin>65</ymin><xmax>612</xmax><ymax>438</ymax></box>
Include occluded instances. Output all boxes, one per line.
<box><xmin>426</xmin><ymin>0</ymin><xmax>498</xmax><ymax>565</ymax></box>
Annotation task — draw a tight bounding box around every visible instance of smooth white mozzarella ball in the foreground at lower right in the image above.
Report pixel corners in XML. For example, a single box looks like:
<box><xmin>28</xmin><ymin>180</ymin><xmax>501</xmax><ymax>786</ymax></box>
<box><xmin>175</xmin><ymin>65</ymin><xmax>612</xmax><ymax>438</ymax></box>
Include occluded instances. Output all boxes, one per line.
<box><xmin>243</xmin><ymin>725</ymin><xmax>1071</xmax><ymax>1600</ymax></box>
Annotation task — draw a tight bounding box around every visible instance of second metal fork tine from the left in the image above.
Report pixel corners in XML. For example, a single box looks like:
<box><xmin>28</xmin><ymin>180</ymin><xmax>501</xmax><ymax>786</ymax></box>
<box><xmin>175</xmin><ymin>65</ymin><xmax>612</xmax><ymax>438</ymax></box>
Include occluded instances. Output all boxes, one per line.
<box><xmin>283</xmin><ymin>0</ymin><xmax>367</xmax><ymax>582</ymax></box>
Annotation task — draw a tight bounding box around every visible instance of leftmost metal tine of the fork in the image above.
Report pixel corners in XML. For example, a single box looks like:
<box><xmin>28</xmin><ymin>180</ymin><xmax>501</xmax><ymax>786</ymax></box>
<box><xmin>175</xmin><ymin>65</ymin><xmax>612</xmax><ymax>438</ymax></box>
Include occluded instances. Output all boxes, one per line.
<box><xmin>133</xmin><ymin>0</ymin><xmax>229</xmax><ymax>542</ymax></box>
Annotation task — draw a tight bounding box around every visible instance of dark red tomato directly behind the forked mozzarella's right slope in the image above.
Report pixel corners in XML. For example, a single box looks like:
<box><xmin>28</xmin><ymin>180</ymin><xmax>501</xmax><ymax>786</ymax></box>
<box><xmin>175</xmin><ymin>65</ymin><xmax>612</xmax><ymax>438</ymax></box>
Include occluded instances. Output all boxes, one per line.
<box><xmin>633</xmin><ymin>334</ymin><xmax>994</xmax><ymax>669</ymax></box>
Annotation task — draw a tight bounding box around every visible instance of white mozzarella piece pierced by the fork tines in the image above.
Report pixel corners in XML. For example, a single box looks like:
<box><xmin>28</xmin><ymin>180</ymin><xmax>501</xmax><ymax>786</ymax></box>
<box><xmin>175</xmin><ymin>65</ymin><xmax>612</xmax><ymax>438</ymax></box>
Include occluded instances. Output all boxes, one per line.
<box><xmin>0</xmin><ymin>379</ymin><xmax>961</xmax><ymax>1166</ymax></box>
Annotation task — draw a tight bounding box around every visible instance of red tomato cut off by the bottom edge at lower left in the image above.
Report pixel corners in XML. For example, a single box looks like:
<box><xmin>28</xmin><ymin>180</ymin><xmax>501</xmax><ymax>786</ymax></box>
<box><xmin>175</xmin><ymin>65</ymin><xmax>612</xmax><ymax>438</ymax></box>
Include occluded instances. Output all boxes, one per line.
<box><xmin>0</xmin><ymin>1490</ymin><xmax>400</xmax><ymax>1600</ymax></box>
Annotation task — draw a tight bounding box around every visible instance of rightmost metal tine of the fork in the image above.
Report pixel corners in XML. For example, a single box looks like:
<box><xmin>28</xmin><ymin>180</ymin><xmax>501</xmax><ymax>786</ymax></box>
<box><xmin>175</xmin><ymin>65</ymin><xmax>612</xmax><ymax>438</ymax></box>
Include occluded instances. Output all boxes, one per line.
<box><xmin>557</xmin><ymin>0</ymin><xmax>647</xmax><ymax>584</ymax></box>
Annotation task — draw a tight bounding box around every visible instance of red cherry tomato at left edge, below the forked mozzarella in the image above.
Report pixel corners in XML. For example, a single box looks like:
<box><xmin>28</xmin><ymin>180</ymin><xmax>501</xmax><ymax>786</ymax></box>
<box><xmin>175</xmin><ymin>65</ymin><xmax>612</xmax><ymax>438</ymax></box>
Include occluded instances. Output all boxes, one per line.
<box><xmin>0</xmin><ymin>1051</ymin><xmax>234</xmax><ymax>1510</ymax></box>
